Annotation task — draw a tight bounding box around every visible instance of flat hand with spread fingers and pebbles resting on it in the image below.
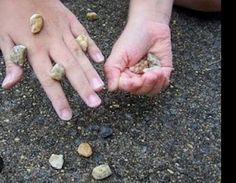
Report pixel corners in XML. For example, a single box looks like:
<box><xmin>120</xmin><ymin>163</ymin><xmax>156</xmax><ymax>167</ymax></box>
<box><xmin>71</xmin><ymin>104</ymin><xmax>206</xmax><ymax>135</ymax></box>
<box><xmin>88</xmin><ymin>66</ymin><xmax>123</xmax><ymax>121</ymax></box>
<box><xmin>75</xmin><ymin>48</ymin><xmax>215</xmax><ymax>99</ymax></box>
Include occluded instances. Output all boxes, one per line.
<box><xmin>0</xmin><ymin>0</ymin><xmax>104</xmax><ymax>120</ymax></box>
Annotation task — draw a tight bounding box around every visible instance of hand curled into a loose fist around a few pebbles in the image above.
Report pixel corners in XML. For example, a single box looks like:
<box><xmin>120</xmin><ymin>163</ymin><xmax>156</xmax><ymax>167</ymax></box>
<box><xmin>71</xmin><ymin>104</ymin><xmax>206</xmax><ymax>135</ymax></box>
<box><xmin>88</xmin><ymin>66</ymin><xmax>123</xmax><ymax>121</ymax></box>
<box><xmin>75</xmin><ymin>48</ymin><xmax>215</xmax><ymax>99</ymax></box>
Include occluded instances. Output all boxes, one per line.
<box><xmin>105</xmin><ymin>20</ymin><xmax>173</xmax><ymax>95</ymax></box>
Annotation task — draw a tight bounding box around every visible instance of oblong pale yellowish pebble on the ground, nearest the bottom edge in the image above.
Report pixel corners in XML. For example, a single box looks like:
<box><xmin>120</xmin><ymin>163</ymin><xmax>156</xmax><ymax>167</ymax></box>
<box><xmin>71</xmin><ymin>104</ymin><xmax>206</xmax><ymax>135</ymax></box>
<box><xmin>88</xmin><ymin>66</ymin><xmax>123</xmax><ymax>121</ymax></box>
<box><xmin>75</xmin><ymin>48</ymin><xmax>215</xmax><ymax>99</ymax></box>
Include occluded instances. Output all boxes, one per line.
<box><xmin>92</xmin><ymin>164</ymin><xmax>112</xmax><ymax>180</ymax></box>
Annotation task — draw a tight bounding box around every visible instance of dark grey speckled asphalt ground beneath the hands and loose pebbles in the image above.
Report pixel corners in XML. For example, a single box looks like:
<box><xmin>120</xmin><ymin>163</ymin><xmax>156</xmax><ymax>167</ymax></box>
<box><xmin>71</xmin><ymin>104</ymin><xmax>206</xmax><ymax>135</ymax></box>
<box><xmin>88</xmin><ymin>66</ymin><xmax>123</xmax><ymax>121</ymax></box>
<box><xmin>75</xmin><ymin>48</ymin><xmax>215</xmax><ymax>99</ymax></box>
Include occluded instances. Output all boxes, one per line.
<box><xmin>0</xmin><ymin>0</ymin><xmax>221</xmax><ymax>183</ymax></box>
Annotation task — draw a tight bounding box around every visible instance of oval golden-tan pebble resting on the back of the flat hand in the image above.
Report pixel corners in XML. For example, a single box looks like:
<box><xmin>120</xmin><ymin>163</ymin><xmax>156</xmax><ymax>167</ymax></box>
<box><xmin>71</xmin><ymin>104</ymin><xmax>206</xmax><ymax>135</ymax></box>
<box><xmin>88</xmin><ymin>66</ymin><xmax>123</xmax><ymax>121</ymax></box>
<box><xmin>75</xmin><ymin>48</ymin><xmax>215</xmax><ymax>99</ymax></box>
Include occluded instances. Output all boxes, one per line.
<box><xmin>30</xmin><ymin>14</ymin><xmax>43</xmax><ymax>34</ymax></box>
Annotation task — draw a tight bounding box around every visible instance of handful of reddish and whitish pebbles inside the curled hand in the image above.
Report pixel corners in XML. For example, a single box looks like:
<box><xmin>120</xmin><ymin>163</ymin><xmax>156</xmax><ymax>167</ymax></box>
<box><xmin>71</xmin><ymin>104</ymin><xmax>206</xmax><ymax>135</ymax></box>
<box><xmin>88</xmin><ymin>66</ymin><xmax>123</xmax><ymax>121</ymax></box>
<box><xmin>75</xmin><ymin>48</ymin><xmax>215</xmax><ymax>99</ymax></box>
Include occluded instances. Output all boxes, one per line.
<box><xmin>129</xmin><ymin>53</ymin><xmax>161</xmax><ymax>74</ymax></box>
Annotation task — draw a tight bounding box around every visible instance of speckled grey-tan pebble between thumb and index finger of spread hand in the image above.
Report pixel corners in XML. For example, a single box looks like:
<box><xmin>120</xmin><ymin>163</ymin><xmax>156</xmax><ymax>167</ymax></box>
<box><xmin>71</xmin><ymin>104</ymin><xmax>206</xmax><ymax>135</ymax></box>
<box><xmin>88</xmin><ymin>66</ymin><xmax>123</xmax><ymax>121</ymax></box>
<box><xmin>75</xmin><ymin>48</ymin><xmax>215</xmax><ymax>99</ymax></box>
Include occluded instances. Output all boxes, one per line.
<box><xmin>10</xmin><ymin>45</ymin><xmax>27</xmax><ymax>66</ymax></box>
